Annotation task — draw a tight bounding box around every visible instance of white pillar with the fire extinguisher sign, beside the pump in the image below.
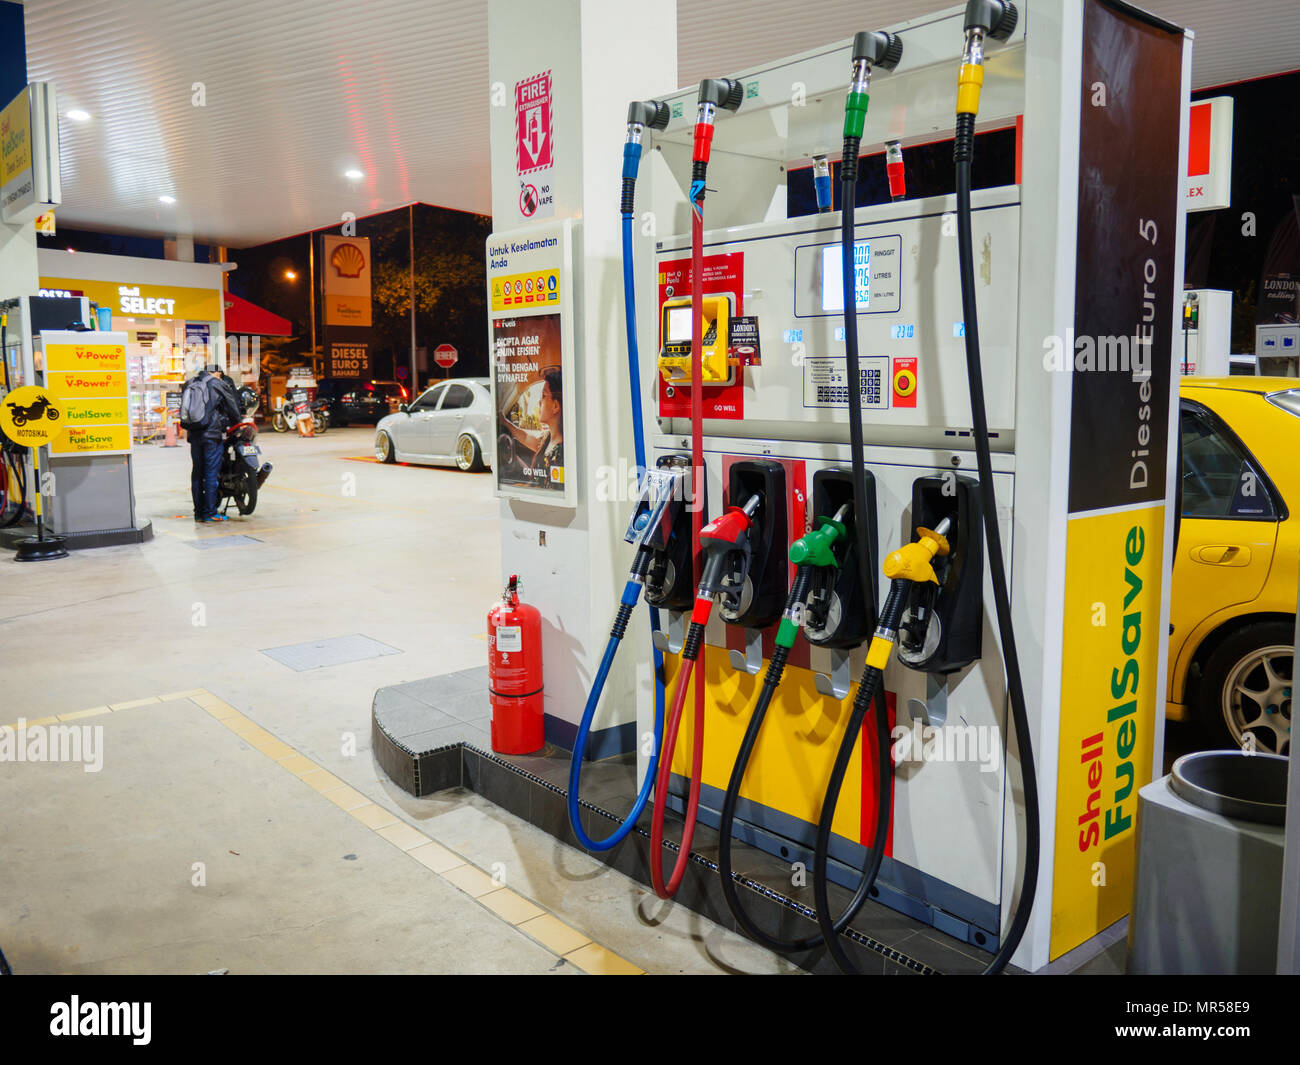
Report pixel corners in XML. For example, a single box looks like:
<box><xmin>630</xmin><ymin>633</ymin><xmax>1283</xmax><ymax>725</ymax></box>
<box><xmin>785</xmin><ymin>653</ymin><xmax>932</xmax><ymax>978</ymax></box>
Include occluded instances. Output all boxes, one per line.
<box><xmin>488</xmin><ymin>0</ymin><xmax>677</xmax><ymax>756</ymax></box>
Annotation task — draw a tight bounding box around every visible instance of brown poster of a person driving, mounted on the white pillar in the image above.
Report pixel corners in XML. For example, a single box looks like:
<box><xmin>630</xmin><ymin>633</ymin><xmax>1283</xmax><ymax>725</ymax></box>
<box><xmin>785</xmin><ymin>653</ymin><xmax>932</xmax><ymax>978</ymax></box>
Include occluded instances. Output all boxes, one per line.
<box><xmin>493</xmin><ymin>313</ymin><xmax>564</xmax><ymax>493</ymax></box>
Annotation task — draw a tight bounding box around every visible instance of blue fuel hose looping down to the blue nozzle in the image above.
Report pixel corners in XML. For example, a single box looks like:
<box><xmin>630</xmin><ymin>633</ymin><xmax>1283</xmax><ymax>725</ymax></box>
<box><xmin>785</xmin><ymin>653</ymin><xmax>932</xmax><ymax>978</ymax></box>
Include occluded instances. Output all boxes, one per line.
<box><xmin>568</xmin><ymin>143</ymin><xmax>664</xmax><ymax>850</ymax></box>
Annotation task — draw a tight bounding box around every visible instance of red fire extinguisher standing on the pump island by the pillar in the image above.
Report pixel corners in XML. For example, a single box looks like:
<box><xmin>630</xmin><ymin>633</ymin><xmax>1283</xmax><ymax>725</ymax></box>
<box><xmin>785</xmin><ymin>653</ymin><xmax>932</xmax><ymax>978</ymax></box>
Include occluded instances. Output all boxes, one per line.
<box><xmin>488</xmin><ymin>573</ymin><xmax>546</xmax><ymax>754</ymax></box>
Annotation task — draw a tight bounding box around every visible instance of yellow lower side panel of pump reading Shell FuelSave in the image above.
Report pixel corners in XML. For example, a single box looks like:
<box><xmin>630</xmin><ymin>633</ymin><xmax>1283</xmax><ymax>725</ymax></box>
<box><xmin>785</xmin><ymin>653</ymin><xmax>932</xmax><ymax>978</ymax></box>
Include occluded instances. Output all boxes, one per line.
<box><xmin>1050</xmin><ymin>503</ymin><xmax>1165</xmax><ymax>958</ymax></box>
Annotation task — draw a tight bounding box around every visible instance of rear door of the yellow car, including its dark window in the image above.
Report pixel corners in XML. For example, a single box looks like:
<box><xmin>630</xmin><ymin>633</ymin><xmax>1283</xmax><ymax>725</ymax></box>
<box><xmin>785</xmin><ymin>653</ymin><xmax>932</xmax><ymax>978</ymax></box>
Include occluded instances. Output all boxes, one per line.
<box><xmin>1169</xmin><ymin>399</ymin><xmax>1279</xmax><ymax>701</ymax></box>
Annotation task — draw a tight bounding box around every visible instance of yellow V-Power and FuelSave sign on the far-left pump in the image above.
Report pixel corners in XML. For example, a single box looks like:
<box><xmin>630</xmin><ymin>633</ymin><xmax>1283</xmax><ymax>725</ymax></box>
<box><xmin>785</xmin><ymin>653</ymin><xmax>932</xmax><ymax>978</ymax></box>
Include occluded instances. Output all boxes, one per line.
<box><xmin>40</xmin><ymin>330</ymin><xmax>131</xmax><ymax>455</ymax></box>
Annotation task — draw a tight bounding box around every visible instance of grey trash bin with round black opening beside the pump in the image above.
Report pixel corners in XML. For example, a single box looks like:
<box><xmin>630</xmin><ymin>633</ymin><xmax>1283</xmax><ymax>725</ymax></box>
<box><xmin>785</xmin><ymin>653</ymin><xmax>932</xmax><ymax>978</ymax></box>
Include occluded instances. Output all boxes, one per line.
<box><xmin>1128</xmin><ymin>750</ymin><xmax>1288</xmax><ymax>974</ymax></box>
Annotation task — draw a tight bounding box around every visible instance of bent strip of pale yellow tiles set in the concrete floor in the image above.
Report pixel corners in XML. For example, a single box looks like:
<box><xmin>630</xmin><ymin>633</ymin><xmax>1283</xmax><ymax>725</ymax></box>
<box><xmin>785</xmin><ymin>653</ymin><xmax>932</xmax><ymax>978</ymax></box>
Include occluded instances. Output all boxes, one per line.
<box><xmin>8</xmin><ymin>688</ymin><xmax>645</xmax><ymax>975</ymax></box>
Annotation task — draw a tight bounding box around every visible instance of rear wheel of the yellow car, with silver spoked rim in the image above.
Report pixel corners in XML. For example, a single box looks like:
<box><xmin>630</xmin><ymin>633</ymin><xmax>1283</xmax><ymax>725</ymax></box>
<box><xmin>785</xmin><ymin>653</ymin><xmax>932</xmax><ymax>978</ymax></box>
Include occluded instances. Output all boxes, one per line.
<box><xmin>1195</xmin><ymin>622</ymin><xmax>1295</xmax><ymax>754</ymax></box>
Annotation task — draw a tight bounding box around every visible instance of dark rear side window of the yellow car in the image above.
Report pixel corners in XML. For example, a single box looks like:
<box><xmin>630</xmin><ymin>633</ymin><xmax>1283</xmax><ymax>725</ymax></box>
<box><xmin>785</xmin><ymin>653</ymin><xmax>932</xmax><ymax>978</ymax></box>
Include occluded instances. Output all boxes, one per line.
<box><xmin>1182</xmin><ymin>403</ymin><xmax>1277</xmax><ymax>520</ymax></box>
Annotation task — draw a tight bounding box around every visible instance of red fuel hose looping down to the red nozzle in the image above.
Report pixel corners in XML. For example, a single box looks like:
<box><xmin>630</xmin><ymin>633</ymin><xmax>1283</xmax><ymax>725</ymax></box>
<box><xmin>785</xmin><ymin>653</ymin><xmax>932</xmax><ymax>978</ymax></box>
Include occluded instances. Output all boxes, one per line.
<box><xmin>650</xmin><ymin>150</ymin><xmax>712</xmax><ymax>899</ymax></box>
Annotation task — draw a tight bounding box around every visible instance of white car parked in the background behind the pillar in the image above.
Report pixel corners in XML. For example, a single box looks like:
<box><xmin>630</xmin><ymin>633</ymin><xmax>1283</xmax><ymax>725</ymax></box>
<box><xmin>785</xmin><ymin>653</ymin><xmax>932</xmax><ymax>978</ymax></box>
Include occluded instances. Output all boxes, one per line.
<box><xmin>374</xmin><ymin>377</ymin><xmax>493</xmax><ymax>471</ymax></box>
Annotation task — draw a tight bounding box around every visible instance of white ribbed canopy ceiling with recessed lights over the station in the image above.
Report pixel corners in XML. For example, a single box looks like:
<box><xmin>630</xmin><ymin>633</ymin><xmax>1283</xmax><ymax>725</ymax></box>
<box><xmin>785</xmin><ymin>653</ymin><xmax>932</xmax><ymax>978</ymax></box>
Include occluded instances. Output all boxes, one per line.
<box><xmin>26</xmin><ymin>0</ymin><xmax>1300</xmax><ymax>247</ymax></box>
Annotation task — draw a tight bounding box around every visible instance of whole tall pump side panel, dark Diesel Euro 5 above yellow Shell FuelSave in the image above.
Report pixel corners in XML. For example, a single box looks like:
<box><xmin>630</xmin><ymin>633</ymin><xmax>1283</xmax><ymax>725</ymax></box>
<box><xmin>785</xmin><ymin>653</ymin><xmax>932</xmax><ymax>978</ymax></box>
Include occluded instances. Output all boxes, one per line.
<box><xmin>1044</xmin><ymin>0</ymin><xmax>1184</xmax><ymax>958</ymax></box>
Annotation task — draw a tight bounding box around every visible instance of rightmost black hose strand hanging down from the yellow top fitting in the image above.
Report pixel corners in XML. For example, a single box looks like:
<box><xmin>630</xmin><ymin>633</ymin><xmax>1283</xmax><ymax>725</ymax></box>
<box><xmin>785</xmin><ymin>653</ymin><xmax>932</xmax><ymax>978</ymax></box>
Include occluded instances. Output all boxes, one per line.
<box><xmin>953</xmin><ymin>113</ymin><xmax>1040</xmax><ymax>975</ymax></box>
